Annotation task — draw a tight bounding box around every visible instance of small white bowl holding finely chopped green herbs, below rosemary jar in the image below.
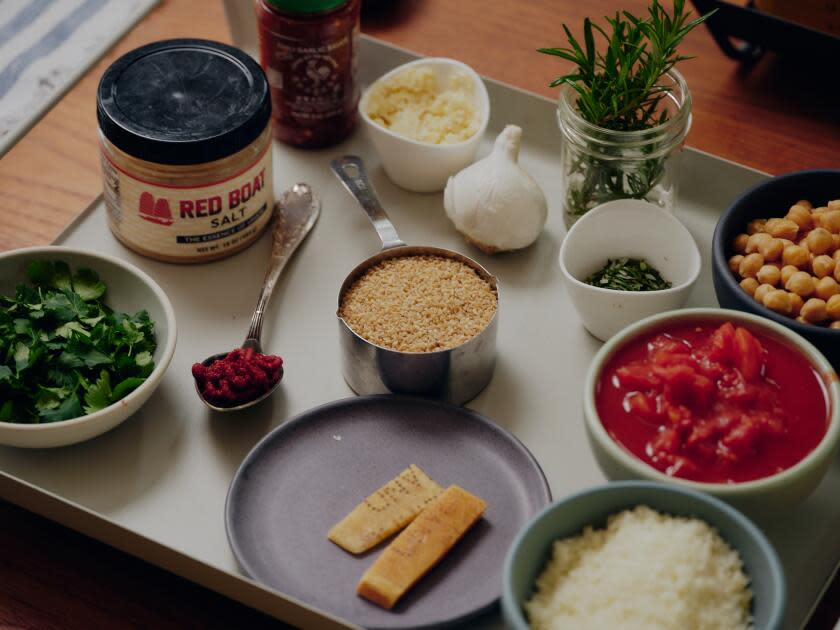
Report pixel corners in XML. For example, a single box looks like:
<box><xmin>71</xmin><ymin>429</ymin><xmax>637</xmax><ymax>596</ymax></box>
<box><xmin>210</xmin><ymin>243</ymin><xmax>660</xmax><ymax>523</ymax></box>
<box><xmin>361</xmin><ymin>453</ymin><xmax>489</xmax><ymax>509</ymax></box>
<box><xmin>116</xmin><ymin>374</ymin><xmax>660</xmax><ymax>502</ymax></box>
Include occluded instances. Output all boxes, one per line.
<box><xmin>560</xmin><ymin>199</ymin><xmax>700</xmax><ymax>341</ymax></box>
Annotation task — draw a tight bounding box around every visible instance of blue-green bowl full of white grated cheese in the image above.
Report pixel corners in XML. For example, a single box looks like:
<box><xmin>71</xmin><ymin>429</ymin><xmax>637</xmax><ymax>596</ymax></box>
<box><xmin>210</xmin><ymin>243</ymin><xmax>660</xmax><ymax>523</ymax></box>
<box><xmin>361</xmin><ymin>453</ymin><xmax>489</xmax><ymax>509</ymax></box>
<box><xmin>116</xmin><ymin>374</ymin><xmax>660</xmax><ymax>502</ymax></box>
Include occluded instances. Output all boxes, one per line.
<box><xmin>502</xmin><ymin>481</ymin><xmax>786</xmax><ymax>630</ymax></box>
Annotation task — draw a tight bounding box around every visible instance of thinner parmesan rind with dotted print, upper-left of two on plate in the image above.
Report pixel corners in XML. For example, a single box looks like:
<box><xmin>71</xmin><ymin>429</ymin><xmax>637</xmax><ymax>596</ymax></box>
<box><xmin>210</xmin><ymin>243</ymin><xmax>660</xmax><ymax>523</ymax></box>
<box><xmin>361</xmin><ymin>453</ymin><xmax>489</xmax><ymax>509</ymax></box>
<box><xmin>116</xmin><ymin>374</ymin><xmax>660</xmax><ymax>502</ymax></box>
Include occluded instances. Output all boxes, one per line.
<box><xmin>327</xmin><ymin>464</ymin><xmax>443</xmax><ymax>553</ymax></box>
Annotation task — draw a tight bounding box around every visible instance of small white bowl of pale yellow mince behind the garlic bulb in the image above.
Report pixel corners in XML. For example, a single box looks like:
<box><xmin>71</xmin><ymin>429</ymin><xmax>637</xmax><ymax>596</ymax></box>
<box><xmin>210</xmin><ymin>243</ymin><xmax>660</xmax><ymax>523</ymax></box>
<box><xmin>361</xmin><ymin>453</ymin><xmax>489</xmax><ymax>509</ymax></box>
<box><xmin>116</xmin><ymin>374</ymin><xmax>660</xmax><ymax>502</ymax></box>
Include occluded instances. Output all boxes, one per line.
<box><xmin>359</xmin><ymin>57</ymin><xmax>490</xmax><ymax>192</ymax></box>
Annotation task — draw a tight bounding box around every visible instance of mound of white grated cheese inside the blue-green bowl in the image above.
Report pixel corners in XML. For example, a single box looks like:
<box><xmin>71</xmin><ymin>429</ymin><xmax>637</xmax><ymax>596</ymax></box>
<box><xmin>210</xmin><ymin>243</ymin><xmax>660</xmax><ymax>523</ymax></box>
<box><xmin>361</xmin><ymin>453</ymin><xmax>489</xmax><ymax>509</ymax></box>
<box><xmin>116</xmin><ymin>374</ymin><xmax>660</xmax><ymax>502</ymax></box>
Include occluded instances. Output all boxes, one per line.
<box><xmin>525</xmin><ymin>506</ymin><xmax>752</xmax><ymax>630</ymax></box>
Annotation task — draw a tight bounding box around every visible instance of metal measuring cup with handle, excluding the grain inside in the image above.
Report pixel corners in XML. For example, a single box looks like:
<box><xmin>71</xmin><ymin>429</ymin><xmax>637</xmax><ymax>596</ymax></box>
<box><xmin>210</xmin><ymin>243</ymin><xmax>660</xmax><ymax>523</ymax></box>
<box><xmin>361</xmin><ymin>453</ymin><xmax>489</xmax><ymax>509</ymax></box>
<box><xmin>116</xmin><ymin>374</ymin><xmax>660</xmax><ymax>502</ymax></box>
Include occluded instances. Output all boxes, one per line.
<box><xmin>330</xmin><ymin>155</ymin><xmax>500</xmax><ymax>405</ymax></box>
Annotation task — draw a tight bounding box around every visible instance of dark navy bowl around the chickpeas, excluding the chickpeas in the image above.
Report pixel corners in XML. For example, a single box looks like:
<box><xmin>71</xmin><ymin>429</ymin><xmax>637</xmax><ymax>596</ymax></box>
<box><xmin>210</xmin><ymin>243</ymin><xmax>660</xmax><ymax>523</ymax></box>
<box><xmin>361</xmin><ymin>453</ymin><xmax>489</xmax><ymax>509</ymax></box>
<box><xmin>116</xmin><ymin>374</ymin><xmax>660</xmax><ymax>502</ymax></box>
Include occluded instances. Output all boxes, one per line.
<box><xmin>712</xmin><ymin>169</ymin><xmax>840</xmax><ymax>368</ymax></box>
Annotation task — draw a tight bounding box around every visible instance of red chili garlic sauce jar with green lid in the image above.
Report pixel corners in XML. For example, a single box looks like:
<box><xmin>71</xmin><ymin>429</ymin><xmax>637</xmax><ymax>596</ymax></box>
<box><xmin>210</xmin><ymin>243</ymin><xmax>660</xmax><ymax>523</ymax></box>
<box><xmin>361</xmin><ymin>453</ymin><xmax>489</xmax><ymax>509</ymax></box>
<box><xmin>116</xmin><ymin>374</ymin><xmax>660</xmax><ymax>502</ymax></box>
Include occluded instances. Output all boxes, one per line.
<box><xmin>255</xmin><ymin>0</ymin><xmax>361</xmax><ymax>148</ymax></box>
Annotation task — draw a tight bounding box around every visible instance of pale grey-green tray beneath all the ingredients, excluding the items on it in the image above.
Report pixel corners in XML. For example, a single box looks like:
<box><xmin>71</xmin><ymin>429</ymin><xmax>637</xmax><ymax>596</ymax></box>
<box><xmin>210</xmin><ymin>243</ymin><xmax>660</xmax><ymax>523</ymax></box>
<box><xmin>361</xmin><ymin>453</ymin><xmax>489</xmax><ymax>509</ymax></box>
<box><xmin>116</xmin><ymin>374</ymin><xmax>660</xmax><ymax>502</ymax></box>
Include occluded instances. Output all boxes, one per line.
<box><xmin>0</xmin><ymin>33</ymin><xmax>840</xmax><ymax>630</ymax></box>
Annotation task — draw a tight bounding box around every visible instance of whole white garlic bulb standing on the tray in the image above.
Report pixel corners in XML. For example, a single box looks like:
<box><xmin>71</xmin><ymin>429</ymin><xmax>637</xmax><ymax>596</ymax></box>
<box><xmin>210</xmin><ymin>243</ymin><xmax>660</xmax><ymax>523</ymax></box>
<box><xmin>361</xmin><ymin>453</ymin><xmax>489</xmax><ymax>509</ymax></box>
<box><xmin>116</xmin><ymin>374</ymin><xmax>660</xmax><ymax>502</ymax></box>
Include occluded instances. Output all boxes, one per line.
<box><xmin>443</xmin><ymin>125</ymin><xmax>548</xmax><ymax>254</ymax></box>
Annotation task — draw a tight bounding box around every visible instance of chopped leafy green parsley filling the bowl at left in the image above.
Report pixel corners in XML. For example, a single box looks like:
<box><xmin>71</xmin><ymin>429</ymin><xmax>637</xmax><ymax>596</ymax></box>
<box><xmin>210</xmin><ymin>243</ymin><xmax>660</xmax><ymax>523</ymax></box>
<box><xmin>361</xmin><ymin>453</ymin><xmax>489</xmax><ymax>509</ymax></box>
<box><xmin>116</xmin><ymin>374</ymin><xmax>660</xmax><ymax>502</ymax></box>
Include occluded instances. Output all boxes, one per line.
<box><xmin>0</xmin><ymin>260</ymin><xmax>157</xmax><ymax>424</ymax></box>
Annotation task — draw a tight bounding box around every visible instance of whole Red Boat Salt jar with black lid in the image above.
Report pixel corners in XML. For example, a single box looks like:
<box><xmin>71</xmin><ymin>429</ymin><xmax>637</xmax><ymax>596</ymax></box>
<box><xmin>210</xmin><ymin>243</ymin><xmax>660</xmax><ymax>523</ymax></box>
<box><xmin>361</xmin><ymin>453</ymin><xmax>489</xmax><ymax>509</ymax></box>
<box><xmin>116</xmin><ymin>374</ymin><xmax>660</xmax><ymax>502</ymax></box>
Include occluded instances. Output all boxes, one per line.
<box><xmin>97</xmin><ymin>39</ymin><xmax>274</xmax><ymax>263</ymax></box>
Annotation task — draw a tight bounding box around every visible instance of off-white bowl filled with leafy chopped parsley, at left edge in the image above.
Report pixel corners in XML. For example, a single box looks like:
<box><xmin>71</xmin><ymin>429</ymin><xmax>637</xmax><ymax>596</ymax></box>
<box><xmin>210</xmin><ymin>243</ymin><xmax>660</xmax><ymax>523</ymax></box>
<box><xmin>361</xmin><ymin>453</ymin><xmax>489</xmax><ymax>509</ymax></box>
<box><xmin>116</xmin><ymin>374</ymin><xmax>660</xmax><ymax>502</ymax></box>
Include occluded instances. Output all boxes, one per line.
<box><xmin>0</xmin><ymin>247</ymin><xmax>176</xmax><ymax>448</ymax></box>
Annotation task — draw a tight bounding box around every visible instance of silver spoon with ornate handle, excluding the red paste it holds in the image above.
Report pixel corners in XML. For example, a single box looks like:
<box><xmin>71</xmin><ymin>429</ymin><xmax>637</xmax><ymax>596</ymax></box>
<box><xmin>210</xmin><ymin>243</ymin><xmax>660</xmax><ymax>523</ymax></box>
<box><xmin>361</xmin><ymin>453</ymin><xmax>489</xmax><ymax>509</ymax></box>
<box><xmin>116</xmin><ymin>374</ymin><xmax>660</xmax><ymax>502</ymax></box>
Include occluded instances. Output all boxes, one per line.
<box><xmin>195</xmin><ymin>184</ymin><xmax>321</xmax><ymax>412</ymax></box>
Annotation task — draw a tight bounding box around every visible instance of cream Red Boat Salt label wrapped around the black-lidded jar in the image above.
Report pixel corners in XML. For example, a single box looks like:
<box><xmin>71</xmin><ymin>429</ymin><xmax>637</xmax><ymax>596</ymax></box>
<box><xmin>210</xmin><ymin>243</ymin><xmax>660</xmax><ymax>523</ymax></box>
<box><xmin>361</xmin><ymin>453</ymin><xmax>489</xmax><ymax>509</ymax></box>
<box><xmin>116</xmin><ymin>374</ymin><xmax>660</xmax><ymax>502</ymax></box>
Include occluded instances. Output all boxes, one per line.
<box><xmin>102</xmin><ymin>144</ymin><xmax>274</xmax><ymax>261</ymax></box>
